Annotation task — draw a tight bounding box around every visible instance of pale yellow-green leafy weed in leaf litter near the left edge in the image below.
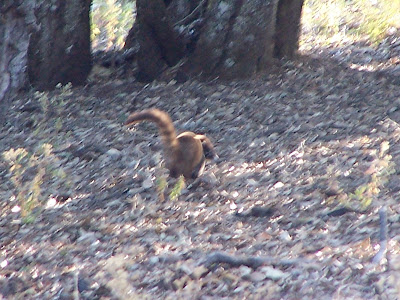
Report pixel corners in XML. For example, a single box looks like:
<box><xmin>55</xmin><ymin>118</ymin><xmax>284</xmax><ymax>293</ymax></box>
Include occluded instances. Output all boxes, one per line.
<box><xmin>3</xmin><ymin>143</ymin><xmax>68</xmax><ymax>223</ymax></box>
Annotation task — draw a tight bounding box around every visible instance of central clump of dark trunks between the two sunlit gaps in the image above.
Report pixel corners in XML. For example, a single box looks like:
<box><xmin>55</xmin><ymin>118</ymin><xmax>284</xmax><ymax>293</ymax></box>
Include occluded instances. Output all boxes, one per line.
<box><xmin>127</xmin><ymin>0</ymin><xmax>304</xmax><ymax>81</ymax></box>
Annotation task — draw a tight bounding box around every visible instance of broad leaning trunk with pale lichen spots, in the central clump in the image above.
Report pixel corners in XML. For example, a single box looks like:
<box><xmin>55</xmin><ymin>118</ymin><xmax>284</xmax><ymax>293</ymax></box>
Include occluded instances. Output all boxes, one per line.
<box><xmin>187</xmin><ymin>0</ymin><xmax>277</xmax><ymax>79</ymax></box>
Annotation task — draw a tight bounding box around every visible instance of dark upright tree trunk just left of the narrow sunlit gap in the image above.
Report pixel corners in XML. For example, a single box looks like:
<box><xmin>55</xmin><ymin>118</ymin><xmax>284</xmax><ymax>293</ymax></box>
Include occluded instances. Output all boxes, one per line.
<box><xmin>28</xmin><ymin>0</ymin><xmax>91</xmax><ymax>90</ymax></box>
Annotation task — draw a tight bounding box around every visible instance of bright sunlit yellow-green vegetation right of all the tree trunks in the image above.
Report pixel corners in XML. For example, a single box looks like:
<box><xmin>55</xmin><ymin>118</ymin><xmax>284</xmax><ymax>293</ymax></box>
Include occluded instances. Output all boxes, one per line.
<box><xmin>302</xmin><ymin>0</ymin><xmax>400</xmax><ymax>45</ymax></box>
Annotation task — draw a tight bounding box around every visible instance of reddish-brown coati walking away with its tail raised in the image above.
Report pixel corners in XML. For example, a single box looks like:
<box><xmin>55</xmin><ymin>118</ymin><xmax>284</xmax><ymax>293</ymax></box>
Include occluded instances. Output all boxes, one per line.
<box><xmin>125</xmin><ymin>109</ymin><xmax>218</xmax><ymax>179</ymax></box>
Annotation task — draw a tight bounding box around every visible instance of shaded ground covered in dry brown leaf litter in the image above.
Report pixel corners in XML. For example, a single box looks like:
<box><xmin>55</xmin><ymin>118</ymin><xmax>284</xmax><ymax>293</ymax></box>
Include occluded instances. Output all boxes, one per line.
<box><xmin>0</xmin><ymin>31</ymin><xmax>400</xmax><ymax>299</ymax></box>
